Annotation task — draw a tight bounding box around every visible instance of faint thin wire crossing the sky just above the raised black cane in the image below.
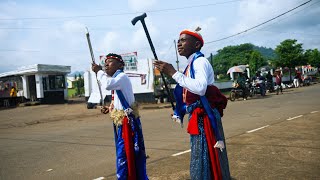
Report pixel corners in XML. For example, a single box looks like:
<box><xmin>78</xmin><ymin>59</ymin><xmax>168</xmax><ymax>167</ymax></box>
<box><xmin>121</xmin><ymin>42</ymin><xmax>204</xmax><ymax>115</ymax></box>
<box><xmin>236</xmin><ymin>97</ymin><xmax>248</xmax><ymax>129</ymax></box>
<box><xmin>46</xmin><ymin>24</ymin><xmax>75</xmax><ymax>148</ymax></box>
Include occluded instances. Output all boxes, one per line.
<box><xmin>0</xmin><ymin>0</ymin><xmax>243</xmax><ymax>21</ymax></box>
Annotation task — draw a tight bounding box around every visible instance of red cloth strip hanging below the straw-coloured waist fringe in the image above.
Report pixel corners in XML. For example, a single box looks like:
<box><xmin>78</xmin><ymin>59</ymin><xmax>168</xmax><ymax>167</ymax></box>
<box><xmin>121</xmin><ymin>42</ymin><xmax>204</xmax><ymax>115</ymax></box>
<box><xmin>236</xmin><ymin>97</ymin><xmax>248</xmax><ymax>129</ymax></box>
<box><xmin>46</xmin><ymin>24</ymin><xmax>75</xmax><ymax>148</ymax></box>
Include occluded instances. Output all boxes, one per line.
<box><xmin>122</xmin><ymin>117</ymin><xmax>137</xmax><ymax>180</ymax></box>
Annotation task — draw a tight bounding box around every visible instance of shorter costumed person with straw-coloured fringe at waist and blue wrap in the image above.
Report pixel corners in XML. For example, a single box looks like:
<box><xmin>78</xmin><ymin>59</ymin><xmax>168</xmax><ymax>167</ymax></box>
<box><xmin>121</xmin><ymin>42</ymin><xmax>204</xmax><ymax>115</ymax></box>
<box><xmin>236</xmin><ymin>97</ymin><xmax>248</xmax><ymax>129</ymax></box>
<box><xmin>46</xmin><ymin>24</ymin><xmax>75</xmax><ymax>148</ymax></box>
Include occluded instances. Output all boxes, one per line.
<box><xmin>92</xmin><ymin>53</ymin><xmax>148</xmax><ymax>180</ymax></box>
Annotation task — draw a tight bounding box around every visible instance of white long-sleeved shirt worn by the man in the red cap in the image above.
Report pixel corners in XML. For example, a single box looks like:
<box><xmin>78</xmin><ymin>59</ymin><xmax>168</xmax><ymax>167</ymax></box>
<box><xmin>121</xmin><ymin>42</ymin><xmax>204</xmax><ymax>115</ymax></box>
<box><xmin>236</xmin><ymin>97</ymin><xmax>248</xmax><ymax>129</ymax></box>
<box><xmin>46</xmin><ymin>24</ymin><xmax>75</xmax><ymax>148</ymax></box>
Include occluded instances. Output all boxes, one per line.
<box><xmin>172</xmin><ymin>53</ymin><xmax>214</xmax><ymax>96</ymax></box>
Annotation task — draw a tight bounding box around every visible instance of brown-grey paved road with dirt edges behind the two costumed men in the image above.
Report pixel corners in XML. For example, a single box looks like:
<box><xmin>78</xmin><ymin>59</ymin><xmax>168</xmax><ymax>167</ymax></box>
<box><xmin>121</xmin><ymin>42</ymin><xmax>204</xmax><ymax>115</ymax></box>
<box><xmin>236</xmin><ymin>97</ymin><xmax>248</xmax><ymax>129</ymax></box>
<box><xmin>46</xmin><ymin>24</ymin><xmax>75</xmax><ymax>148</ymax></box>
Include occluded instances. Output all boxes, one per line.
<box><xmin>0</xmin><ymin>85</ymin><xmax>320</xmax><ymax>179</ymax></box>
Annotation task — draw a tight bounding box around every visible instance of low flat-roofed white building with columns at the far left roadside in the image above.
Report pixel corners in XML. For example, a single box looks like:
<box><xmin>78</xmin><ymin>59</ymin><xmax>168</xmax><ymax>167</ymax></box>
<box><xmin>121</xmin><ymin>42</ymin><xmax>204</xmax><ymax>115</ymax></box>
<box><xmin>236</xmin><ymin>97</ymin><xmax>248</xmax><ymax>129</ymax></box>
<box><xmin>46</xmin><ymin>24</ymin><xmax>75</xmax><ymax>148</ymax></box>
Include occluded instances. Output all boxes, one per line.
<box><xmin>0</xmin><ymin>64</ymin><xmax>71</xmax><ymax>103</ymax></box>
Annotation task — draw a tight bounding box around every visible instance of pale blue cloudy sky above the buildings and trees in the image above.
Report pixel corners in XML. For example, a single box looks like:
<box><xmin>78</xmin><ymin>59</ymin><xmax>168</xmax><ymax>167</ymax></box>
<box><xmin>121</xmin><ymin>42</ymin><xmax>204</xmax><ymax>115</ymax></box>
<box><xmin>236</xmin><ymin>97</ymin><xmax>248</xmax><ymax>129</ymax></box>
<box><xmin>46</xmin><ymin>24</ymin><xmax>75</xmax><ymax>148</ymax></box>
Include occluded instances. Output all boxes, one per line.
<box><xmin>0</xmin><ymin>0</ymin><xmax>320</xmax><ymax>73</ymax></box>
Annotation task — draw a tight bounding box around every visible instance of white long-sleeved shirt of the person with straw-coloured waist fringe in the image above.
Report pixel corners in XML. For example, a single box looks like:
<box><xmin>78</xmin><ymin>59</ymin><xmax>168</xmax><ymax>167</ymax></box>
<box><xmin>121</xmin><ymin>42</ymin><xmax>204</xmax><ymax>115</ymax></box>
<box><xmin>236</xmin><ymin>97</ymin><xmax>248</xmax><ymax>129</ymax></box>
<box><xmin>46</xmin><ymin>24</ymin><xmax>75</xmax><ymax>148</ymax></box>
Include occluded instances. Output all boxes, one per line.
<box><xmin>97</xmin><ymin>70</ymin><xmax>135</xmax><ymax>110</ymax></box>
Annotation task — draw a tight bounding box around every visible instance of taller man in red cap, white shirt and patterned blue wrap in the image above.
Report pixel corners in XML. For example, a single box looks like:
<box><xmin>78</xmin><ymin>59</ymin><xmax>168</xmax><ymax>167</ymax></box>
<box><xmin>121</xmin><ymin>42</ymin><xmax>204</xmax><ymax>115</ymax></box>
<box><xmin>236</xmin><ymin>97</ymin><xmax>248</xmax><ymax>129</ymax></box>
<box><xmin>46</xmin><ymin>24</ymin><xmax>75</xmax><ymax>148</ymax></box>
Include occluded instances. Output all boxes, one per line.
<box><xmin>154</xmin><ymin>28</ymin><xmax>231</xmax><ymax>180</ymax></box>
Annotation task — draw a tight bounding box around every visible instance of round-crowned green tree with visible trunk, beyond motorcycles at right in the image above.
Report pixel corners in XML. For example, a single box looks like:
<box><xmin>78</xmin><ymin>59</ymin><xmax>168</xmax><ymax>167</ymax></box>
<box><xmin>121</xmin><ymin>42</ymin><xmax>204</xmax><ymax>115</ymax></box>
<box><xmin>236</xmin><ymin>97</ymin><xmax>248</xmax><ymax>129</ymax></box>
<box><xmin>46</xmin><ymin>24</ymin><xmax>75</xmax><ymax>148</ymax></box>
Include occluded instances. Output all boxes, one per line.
<box><xmin>273</xmin><ymin>39</ymin><xmax>303</xmax><ymax>81</ymax></box>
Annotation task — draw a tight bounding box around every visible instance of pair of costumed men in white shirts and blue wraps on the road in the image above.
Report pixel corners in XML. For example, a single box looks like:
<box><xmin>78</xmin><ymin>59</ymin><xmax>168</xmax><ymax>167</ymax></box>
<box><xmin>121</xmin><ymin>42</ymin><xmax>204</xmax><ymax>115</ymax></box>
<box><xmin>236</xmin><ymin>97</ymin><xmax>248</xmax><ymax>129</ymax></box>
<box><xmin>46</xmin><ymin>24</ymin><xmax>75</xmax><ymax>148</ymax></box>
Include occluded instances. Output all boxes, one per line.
<box><xmin>92</xmin><ymin>28</ymin><xmax>231</xmax><ymax>180</ymax></box>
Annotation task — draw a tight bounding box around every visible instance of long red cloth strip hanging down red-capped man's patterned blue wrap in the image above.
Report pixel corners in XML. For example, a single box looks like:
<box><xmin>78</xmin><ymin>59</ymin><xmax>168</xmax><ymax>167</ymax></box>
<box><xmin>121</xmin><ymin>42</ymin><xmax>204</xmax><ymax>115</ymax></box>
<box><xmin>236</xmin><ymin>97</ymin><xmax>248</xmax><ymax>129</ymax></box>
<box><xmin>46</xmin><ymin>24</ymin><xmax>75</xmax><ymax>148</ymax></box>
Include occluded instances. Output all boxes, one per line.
<box><xmin>203</xmin><ymin>115</ymin><xmax>222</xmax><ymax>180</ymax></box>
